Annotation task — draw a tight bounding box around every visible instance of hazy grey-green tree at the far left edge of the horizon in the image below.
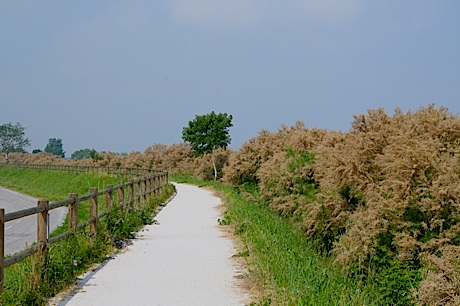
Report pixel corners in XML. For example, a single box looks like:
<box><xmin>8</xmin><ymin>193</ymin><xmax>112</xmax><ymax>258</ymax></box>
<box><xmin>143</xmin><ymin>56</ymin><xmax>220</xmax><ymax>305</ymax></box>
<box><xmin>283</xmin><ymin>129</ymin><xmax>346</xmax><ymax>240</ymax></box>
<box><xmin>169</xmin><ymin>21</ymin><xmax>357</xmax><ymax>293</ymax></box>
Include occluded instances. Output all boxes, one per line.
<box><xmin>0</xmin><ymin>122</ymin><xmax>30</xmax><ymax>163</ymax></box>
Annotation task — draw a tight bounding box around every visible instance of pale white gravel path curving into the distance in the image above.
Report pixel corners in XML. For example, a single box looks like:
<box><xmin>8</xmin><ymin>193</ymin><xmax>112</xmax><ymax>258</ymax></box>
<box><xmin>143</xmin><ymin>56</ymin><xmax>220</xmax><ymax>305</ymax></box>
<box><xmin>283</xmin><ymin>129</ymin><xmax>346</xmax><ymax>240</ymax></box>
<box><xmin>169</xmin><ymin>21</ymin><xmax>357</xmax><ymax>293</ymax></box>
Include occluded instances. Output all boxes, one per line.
<box><xmin>55</xmin><ymin>184</ymin><xmax>249</xmax><ymax>306</ymax></box>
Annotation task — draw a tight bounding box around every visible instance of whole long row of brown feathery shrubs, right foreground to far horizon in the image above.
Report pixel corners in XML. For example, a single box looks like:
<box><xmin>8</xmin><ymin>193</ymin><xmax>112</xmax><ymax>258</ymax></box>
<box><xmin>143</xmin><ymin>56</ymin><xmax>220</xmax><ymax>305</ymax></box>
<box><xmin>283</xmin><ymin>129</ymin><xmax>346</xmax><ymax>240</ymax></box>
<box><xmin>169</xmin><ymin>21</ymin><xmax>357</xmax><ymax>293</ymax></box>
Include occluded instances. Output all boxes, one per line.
<box><xmin>0</xmin><ymin>105</ymin><xmax>460</xmax><ymax>305</ymax></box>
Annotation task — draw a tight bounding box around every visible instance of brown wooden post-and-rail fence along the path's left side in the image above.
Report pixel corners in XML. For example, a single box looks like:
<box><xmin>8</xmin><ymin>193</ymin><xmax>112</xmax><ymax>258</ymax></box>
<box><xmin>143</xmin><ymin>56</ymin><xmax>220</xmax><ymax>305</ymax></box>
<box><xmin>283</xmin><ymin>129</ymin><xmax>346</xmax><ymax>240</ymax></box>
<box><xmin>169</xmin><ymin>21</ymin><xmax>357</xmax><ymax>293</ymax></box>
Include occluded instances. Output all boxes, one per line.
<box><xmin>0</xmin><ymin>165</ymin><xmax>168</xmax><ymax>294</ymax></box>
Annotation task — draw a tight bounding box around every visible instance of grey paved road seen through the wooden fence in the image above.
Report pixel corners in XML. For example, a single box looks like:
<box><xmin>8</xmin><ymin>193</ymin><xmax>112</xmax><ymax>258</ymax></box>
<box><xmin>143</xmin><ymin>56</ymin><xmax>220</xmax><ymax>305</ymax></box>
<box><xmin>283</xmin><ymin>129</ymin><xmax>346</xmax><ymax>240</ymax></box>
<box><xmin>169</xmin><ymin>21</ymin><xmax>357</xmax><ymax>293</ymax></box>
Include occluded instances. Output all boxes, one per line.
<box><xmin>0</xmin><ymin>187</ymin><xmax>67</xmax><ymax>255</ymax></box>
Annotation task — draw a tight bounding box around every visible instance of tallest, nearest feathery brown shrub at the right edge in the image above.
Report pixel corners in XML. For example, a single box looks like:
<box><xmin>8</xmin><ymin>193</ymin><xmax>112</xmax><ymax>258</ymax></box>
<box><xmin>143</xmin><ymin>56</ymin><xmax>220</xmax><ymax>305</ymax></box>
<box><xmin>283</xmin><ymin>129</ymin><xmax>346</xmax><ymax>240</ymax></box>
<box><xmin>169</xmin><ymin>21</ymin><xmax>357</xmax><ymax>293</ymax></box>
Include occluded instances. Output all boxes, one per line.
<box><xmin>314</xmin><ymin>106</ymin><xmax>460</xmax><ymax>298</ymax></box>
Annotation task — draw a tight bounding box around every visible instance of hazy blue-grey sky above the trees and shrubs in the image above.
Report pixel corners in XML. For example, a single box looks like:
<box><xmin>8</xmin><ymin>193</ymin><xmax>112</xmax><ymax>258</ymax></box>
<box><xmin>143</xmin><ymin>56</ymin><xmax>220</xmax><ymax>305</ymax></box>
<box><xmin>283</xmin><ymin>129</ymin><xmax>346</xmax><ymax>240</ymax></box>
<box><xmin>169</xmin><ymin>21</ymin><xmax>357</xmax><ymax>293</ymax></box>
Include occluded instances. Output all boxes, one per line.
<box><xmin>0</xmin><ymin>0</ymin><xmax>460</xmax><ymax>157</ymax></box>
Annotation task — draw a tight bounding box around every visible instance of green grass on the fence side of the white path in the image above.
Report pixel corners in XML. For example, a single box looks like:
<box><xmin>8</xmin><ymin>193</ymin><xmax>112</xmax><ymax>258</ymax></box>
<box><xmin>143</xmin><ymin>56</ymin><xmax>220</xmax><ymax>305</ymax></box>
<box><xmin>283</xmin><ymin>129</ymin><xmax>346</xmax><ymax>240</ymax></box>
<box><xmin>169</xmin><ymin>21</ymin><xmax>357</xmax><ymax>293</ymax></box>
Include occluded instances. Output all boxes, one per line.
<box><xmin>0</xmin><ymin>168</ymin><xmax>174</xmax><ymax>305</ymax></box>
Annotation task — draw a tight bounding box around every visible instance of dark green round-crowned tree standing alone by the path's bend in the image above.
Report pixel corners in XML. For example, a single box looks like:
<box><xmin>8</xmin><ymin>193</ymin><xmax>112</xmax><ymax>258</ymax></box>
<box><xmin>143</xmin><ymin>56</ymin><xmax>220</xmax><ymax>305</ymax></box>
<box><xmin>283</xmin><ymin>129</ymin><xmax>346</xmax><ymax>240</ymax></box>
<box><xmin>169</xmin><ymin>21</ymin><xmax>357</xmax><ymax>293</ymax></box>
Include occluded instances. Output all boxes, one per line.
<box><xmin>182</xmin><ymin>112</ymin><xmax>233</xmax><ymax>180</ymax></box>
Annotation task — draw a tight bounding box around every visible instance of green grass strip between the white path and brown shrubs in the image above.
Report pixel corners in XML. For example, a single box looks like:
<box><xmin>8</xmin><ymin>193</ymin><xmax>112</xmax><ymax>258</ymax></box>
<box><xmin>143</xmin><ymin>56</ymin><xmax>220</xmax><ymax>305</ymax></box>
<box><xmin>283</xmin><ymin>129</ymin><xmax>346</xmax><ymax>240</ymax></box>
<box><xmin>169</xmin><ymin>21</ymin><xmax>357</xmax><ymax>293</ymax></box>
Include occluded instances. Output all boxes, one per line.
<box><xmin>172</xmin><ymin>176</ymin><xmax>380</xmax><ymax>306</ymax></box>
